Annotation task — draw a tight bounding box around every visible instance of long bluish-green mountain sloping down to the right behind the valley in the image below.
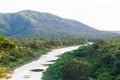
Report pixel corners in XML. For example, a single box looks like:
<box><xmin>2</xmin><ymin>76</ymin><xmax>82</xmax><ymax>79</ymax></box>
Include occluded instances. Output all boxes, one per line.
<box><xmin>0</xmin><ymin>10</ymin><xmax>116</xmax><ymax>38</ymax></box>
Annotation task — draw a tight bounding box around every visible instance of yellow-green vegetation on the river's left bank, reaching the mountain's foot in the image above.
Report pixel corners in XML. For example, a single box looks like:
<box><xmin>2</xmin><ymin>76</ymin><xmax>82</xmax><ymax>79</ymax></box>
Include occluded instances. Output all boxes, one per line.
<box><xmin>0</xmin><ymin>34</ymin><xmax>87</xmax><ymax>78</ymax></box>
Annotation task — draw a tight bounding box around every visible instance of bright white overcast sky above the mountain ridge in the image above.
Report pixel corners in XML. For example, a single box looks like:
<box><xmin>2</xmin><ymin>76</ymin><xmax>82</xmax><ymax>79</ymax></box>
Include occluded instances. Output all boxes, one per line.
<box><xmin>0</xmin><ymin>0</ymin><xmax>120</xmax><ymax>31</ymax></box>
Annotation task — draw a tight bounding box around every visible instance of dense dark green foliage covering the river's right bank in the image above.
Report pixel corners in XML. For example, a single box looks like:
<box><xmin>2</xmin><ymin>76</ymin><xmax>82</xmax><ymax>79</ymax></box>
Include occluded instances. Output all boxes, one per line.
<box><xmin>43</xmin><ymin>39</ymin><xmax>120</xmax><ymax>80</ymax></box>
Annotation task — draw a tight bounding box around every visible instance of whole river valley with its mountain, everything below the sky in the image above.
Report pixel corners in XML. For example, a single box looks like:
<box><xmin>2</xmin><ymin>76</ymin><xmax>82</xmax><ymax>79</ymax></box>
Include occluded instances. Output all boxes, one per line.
<box><xmin>0</xmin><ymin>10</ymin><xmax>120</xmax><ymax>80</ymax></box>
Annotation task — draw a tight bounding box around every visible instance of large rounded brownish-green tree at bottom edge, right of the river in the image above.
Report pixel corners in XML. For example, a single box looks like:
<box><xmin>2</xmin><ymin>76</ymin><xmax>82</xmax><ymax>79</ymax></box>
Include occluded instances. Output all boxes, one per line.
<box><xmin>60</xmin><ymin>59</ymin><xmax>91</xmax><ymax>80</ymax></box>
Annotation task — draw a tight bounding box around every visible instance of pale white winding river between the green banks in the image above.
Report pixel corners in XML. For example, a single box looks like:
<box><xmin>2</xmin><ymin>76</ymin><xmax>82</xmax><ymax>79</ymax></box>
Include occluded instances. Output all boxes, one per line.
<box><xmin>9</xmin><ymin>46</ymin><xmax>79</xmax><ymax>80</ymax></box>
